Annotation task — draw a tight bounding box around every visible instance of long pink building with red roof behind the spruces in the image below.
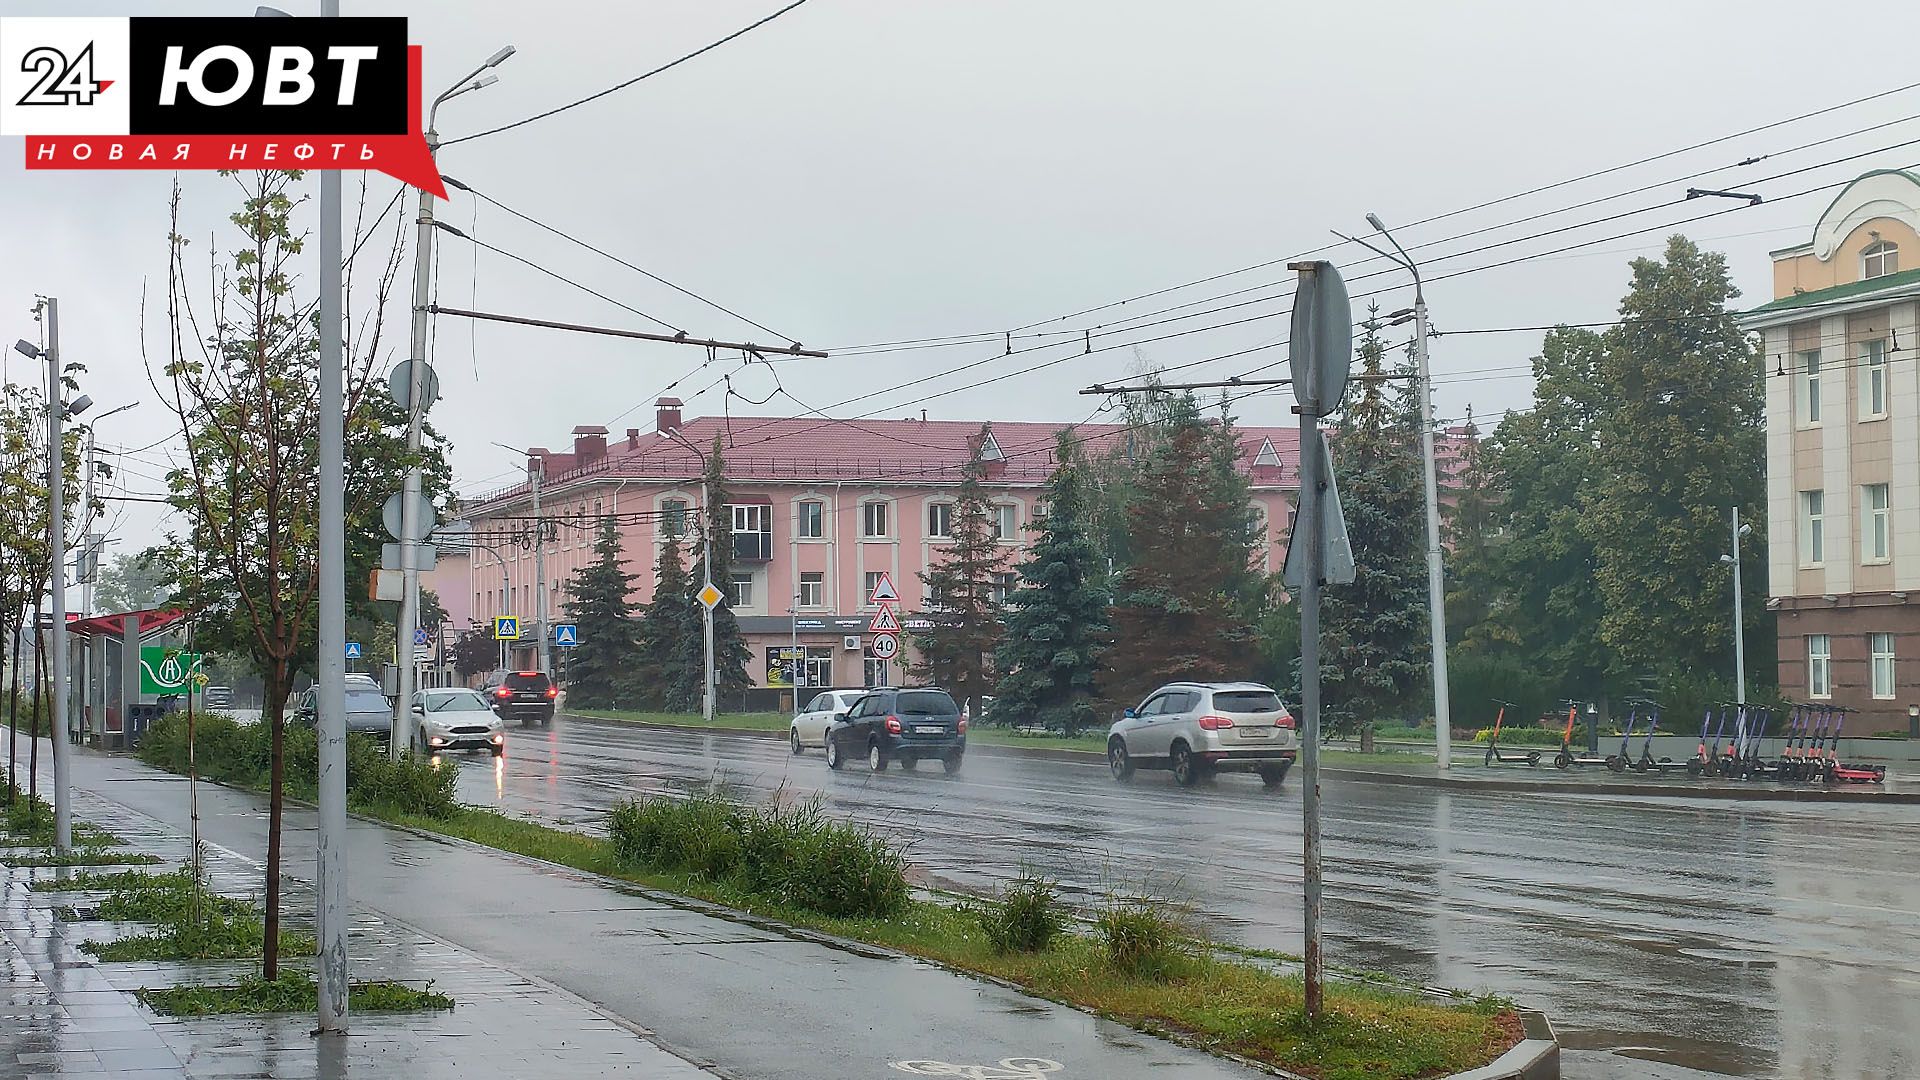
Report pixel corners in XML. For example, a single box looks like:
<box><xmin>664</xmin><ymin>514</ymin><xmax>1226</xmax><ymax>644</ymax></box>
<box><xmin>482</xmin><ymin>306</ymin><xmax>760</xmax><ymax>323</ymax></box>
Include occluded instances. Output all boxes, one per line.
<box><xmin>426</xmin><ymin>398</ymin><xmax>1320</xmax><ymax>686</ymax></box>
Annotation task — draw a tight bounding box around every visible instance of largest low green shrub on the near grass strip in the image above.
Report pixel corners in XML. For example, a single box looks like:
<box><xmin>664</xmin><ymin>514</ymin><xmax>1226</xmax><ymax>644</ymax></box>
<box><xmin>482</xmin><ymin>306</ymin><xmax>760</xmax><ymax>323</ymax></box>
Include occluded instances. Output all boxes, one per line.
<box><xmin>607</xmin><ymin>790</ymin><xmax>908</xmax><ymax>919</ymax></box>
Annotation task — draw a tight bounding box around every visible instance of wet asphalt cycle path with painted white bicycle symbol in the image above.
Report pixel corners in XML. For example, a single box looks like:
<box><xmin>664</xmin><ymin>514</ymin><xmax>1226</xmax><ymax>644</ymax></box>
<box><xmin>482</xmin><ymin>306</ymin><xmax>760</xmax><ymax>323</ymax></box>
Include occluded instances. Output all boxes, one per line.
<box><xmin>41</xmin><ymin>751</ymin><xmax>1256</xmax><ymax>1080</ymax></box>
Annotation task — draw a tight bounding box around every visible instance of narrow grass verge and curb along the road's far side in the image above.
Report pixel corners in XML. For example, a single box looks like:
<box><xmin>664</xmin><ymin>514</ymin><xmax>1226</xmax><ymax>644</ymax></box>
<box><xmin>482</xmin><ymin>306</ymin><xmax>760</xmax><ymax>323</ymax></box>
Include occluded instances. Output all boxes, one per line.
<box><xmin>563</xmin><ymin>713</ymin><xmax>1920</xmax><ymax>805</ymax></box>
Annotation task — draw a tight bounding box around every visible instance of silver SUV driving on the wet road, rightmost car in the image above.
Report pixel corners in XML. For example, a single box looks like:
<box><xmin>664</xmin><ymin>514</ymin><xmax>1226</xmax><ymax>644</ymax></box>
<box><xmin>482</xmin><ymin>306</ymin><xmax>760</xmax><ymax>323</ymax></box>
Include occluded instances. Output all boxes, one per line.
<box><xmin>1106</xmin><ymin>682</ymin><xmax>1300</xmax><ymax>788</ymax></box>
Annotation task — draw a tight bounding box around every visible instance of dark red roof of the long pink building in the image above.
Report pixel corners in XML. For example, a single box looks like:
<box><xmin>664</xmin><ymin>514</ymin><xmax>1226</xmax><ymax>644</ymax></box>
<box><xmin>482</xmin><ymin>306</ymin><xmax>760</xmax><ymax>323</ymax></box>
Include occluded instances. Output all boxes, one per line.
<box><xmin>474</xmin><ymin>417</ymin><xmax>1300</xmax><ymax>505</ymax></box>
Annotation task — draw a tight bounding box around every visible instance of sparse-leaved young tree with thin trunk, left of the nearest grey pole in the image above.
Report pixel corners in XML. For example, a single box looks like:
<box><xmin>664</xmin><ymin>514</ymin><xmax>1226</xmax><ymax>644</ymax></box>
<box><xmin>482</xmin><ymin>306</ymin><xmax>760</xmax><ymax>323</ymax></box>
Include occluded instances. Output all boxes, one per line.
<box><xmin>142</xmin><ymin>173</ymin><xmax>401</xmax><ymax>978</ymax></box>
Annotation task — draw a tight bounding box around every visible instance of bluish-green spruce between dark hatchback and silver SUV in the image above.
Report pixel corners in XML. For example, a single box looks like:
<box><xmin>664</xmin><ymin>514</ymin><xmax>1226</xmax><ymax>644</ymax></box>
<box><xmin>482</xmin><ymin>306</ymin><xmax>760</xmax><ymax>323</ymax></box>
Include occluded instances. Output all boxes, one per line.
<box><xmin>993</xmin><ymin>430</ymin><xmax>1114</xmax><ymax>736</ymax></box>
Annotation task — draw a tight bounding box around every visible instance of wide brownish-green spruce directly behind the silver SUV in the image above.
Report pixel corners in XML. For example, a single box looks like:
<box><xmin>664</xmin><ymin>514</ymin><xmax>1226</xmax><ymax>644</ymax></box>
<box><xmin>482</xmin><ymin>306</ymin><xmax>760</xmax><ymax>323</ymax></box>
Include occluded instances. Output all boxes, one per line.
<box><xmin>1104</xmin><ymin>394</ymin><xmax>1256</xmax><ymax>705</ymax></box>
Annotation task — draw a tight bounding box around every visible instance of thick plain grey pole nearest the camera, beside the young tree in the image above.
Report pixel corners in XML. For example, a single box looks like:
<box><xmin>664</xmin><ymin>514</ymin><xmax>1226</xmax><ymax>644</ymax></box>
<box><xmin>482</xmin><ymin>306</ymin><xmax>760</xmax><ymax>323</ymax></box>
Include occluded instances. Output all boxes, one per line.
<box><xmin>313</xmin><ymin>0</ymin><xmax>349</xmax><ymax>1034</ymax></box>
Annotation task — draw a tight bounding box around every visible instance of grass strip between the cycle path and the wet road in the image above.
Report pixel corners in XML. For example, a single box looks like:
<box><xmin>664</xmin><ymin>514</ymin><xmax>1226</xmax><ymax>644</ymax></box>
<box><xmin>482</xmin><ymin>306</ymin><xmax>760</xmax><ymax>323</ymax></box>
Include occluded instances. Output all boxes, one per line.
<box><xmin>374</xmin><ymin>801</ymin><xmax>1519</xmax><ymax>1080</ymax></box>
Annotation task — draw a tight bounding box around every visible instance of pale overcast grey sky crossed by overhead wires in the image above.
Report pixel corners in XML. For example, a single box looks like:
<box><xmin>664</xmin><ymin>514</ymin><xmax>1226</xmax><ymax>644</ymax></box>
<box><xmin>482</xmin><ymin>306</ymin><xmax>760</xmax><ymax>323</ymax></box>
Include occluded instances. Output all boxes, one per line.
<box><xmin>0</xmin><ymin>0</ymin><xmax>1920</xmax><ymax>550</ymax></box>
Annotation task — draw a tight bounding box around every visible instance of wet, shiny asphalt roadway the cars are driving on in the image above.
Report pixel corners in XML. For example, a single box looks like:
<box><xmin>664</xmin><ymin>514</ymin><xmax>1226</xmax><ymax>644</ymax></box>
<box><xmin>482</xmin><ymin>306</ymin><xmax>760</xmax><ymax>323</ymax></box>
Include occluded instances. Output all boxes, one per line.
<box><xmin>445</xmin><ymin>717</ymin><xmax>1920</xmax><ymax>1080</ymax></box>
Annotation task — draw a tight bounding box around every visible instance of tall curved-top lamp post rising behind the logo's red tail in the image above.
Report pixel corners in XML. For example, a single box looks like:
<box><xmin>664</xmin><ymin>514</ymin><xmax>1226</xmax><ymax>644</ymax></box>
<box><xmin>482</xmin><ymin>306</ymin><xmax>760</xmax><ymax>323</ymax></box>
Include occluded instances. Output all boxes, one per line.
<box><xmin>388</xmin><ymin>44</ymin><xmax>513</xmax><ymax>757</ymax></box>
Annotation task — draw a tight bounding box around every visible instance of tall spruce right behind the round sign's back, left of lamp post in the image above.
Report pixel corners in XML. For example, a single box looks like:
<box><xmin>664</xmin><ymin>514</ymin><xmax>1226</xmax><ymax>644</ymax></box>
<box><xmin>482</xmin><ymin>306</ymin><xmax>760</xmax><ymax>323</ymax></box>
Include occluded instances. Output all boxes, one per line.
<box><xmin>1321</xmin><ymin>309</ymin><xmax>1430</xmax><ymax>723</ymax></box>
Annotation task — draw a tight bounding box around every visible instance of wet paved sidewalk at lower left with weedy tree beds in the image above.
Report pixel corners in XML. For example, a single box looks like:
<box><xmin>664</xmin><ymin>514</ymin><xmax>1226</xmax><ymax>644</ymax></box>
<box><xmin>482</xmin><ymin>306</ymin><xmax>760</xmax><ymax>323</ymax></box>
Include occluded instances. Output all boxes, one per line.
<box><xmin>0</xmin><ymin>772</ymin><xmax>712</xmax><ymax>1080</ymax></box>
